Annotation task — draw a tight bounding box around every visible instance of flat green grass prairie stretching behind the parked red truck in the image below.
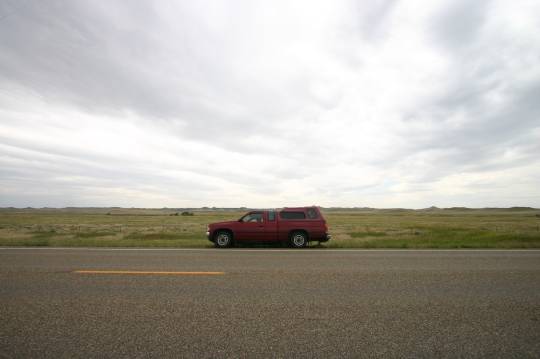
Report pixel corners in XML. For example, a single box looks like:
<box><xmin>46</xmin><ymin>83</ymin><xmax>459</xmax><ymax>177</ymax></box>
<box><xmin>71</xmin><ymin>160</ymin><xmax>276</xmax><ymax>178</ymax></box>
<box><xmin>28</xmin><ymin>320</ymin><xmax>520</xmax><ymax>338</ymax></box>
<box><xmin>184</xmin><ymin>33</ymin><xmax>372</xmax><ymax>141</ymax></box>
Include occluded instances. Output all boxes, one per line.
<box><xmin>0</xmin><ymin>208</ymin><xmax>540</xmax><ymax>248</ymax></box>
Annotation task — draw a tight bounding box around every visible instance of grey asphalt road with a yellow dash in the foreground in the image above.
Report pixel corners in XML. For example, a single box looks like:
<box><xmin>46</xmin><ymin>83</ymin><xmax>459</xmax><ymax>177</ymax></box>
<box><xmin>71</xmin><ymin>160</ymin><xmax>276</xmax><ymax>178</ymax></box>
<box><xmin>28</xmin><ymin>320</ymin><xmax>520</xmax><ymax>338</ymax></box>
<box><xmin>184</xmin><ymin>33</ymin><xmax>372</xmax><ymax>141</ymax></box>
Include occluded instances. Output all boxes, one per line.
<box><xmin>0</xmin><ymin>248</ymin><xmax>540</xmax><ymax>358</ymax></box>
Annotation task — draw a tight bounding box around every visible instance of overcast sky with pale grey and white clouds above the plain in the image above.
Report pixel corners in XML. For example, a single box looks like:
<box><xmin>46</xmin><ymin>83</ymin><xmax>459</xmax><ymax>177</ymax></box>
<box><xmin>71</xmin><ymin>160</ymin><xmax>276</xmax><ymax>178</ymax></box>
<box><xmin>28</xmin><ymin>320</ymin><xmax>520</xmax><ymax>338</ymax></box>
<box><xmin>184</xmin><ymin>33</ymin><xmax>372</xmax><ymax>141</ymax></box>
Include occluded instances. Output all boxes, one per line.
<box><xmin>0</xmin><ymin>0</ymin><xmax>540</xmax><ymax>208</ymax></box>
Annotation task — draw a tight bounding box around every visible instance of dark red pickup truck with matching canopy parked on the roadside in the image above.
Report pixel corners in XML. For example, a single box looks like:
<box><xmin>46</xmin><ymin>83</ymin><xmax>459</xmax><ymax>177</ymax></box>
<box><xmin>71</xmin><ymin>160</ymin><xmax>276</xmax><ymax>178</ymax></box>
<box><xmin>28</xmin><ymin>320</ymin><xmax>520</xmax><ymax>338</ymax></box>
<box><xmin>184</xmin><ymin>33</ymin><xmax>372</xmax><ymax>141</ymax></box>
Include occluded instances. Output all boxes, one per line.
<box><xmin>206</xmin><ymin>207</ymin><xmax>331</xmax><ymax>248</ymax></box>
